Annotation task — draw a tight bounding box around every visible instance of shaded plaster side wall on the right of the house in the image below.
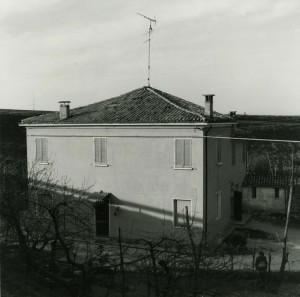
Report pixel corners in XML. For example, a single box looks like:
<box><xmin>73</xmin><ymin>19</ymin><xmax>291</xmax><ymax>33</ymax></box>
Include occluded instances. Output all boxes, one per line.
<box><xmin>207</xmin><ymin>127</ymin><xmax>246</xmax><ymax>238</ymax></box>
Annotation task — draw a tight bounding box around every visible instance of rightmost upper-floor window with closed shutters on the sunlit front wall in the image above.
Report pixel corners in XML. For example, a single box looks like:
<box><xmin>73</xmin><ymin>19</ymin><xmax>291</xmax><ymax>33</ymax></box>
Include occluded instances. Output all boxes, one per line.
<box><xmin>175</xmin><ymin>139</ymin><xmax>192</xmax><ymax>168</ymax></box>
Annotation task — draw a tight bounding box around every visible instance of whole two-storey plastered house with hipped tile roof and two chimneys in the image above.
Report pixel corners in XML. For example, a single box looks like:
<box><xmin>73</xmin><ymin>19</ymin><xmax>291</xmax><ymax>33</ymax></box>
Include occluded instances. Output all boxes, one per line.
<box><xmin>21</xmin><ymin>87</ymin><xmax>246</xmax><ymax>238</ymax></box>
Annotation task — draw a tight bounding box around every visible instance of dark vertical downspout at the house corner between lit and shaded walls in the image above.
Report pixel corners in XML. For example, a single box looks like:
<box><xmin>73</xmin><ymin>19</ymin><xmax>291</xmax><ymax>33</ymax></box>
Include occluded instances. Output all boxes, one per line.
<box><xmin>203</xmin><ymin>125</ymin><xmax>212</xmax><ymax>243</ymax></box>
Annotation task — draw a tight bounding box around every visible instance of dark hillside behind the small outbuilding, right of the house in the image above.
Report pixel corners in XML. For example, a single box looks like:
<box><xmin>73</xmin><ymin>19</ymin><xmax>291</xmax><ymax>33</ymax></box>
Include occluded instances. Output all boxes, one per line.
<box><xmin>237</xmin><ymin>115</ymin><xmax>300</xmax><ymax>175</ymax></box>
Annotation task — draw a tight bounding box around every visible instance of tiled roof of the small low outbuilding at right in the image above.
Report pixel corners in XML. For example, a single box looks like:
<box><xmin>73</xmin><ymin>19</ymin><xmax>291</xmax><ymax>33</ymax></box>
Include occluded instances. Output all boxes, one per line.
<box><xmin>243</xmin><ymin>174</ymin><xmax>299</xmax><ymax>188</ymax></box>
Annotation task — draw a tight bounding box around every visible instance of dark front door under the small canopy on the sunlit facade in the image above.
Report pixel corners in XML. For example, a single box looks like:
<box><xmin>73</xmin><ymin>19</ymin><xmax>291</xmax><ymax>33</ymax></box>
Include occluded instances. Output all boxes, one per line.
<box><xmin>95</xmin><ymin>201</ymin><xmax>109</xmax><ymax>236</ymax></box>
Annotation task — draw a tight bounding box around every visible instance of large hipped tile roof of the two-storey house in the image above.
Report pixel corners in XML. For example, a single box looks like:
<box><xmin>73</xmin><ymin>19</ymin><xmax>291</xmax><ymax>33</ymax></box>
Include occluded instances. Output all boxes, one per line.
<box><xmin>22</xmin><ymin>87</ymin><xmax>234</xmax><ymax>124</ymax></box>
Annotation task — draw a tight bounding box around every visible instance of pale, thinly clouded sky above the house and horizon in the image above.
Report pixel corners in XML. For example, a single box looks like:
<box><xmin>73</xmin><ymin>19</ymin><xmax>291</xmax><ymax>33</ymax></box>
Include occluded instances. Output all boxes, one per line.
<box><xmin>0</xmin><ymin>0</ymin><xmax>300</xmax><ymax>115</ymax></box>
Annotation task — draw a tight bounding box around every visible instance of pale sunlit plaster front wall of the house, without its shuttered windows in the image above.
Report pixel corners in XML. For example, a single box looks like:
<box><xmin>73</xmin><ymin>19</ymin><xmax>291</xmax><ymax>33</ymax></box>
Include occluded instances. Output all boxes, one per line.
<box><xmin>27</xmin><ymin>126</ymin><xmax>204</xmax><ymax>237</ymax></box>
